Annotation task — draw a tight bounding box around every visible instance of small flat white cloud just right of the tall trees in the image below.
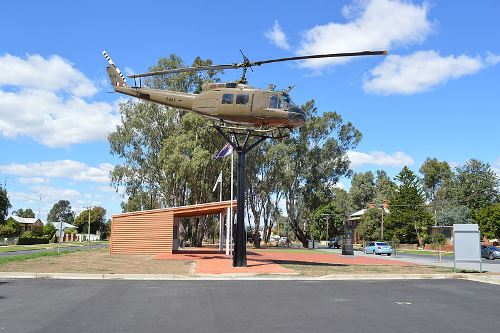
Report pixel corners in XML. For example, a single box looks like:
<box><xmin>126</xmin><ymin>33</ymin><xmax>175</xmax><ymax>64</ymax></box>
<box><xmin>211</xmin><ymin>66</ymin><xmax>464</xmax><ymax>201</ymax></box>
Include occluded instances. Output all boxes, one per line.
<box><xmin>347</xmin><ymin>151</ymin><xmax>413</xmax><ymax>168</ymax></box>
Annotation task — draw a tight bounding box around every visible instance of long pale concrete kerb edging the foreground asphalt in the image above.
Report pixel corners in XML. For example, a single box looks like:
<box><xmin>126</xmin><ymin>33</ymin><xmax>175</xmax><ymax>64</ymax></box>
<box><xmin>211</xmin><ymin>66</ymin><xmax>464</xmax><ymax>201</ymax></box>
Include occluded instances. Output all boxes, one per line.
<box><xmin>0</xmin><ymin>272</ymin><xmax>500</xmax><ymax>285</ymax></box>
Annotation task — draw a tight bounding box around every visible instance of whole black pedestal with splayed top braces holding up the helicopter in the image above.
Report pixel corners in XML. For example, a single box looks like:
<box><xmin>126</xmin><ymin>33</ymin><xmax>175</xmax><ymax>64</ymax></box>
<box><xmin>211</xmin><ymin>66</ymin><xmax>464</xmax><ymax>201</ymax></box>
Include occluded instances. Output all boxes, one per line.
<box><xmin>214</xmin><ymin>126</ymin><xmax>271</xmax><ymax>267</ymax></box>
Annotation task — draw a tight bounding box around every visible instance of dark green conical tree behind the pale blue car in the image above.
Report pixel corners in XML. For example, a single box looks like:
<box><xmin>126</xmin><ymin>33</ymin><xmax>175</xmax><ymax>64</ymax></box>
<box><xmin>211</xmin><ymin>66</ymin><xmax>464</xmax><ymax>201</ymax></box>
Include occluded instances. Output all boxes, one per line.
<box><xmin>384</xmin><ymin>166</ymin><xmax>433</xmax><ymax>246</ymax></box>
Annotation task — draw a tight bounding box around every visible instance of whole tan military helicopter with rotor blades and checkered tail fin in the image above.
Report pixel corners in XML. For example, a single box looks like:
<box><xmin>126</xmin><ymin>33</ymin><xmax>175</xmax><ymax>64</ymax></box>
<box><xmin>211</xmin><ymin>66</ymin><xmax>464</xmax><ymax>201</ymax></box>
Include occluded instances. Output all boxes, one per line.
<box><xmin>102</xmin><ymin>50</ymin><xmax>387</xmax><ymax>132</ymax></box>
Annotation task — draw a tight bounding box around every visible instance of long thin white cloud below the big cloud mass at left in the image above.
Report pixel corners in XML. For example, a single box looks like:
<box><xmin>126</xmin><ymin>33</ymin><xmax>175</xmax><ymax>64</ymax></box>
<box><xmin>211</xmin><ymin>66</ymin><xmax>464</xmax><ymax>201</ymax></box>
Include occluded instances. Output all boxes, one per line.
<box><xmin>0</xmin><ymin>160</ymin><xmax>113</xmax><ymax>183</ymax></box>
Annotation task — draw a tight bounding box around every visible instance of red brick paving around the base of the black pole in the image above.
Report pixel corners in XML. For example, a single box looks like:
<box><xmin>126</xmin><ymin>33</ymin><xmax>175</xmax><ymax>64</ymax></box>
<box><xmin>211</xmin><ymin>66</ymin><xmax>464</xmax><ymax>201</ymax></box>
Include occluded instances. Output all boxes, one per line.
<box><xmin>154</xmin><ymin>248</ymin><xmax>413</xmax><ymax>274</ymax></box>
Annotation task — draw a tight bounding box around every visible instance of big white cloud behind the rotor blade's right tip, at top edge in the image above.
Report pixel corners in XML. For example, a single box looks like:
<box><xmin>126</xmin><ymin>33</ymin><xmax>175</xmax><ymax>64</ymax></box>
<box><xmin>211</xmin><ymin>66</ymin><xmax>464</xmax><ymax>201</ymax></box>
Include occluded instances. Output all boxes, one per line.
<box><xmin>297</xmin><ymin>0</ymin><xmax>433</xmax><ymax>69</ymax></box>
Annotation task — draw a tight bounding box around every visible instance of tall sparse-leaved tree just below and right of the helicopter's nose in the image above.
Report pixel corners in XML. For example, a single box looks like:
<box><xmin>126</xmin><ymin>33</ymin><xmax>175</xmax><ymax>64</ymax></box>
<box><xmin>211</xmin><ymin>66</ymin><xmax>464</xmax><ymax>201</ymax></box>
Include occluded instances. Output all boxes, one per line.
<box><xmin>275</xmin><ymin>100</ymin><xmax>361</xmax><ymax>246</ymax></box>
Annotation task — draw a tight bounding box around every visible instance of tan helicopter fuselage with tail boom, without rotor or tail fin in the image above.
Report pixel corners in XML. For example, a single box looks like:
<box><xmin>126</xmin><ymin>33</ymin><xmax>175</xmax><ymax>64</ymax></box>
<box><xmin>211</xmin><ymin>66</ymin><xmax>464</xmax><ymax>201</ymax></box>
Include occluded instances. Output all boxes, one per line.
<box><xmin>114</xmin><ymin>82</ymin><xmax>305</xmax><ymax>128</ymax></box>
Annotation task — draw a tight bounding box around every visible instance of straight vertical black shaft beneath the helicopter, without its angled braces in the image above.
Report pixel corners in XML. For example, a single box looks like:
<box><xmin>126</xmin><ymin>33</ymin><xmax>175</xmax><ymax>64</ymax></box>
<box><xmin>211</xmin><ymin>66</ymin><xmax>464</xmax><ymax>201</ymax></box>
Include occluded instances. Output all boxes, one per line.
<box><xmin>233</xmin><ymin>149</ymin><xmax>247</xmax><ymax>267</ymax></box>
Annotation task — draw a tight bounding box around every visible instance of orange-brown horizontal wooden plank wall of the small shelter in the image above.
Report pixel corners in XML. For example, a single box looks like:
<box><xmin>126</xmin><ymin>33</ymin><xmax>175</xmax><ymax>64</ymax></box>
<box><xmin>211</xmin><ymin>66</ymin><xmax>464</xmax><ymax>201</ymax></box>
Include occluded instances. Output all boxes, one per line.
<box><xmin>110</xmin><ymin>211</ymin><xmax>174</xmax><ymax>254</ymax></box>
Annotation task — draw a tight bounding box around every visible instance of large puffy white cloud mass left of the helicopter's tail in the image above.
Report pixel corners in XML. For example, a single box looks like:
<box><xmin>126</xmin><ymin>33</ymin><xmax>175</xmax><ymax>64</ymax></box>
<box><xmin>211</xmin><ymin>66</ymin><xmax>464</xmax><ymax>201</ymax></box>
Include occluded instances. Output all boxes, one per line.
<box><xmin>0</xmin><ymin>54</ymin><xmax>119</xmax><ymax>147</ymax></box>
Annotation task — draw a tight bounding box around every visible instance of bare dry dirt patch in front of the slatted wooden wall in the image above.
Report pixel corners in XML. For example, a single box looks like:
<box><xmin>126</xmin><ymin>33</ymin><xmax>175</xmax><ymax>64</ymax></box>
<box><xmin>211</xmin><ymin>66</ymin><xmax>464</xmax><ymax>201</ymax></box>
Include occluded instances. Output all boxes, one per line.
<box><xmin>0</xmin><ymin>249</ymin><xmax>195</xmax><ymax>275</ymax></box>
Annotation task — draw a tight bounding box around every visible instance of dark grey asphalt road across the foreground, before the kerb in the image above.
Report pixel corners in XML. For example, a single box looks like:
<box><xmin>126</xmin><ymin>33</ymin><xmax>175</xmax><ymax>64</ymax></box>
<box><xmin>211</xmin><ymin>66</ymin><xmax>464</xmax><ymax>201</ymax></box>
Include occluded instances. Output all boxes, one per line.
<box><xmin>0</xmin><ymin>279</ymin><xmax>500</xmax><ymax>333</ymax></box>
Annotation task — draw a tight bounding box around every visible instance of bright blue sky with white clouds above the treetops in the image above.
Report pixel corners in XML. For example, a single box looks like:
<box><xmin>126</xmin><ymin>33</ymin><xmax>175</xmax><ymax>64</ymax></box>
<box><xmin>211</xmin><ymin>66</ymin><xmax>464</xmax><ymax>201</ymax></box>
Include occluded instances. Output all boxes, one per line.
<box><xmin>0</xmin><ymin>0</ymin><xmax>500</xmax><ymax>218</ymax></box>
